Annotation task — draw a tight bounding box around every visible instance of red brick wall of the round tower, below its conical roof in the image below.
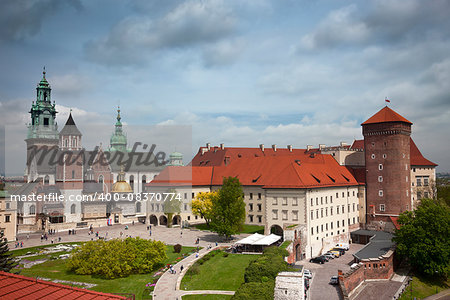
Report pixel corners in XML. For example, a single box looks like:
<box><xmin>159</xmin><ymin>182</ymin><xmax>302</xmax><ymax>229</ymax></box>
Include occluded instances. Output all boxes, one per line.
<box><xmin>363</xmin><ymin>122</ymin><xmax>411</xmax><ymax>223</ymax></box>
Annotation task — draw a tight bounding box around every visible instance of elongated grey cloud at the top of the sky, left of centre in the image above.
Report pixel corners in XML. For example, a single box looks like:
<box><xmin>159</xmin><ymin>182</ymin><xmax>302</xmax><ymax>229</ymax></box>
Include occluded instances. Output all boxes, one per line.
<box><xmin>85</xmin><ymin>1</ymin><xmax>236</xmax><ymax>65</ymax></box>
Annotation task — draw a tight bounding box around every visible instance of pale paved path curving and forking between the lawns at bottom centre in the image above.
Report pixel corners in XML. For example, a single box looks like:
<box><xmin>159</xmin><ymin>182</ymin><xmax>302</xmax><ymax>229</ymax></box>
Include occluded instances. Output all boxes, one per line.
<box><xmin>153</xmin><ymin>244</ymin><xmax>234</xmax><ymax>300</ymax></box>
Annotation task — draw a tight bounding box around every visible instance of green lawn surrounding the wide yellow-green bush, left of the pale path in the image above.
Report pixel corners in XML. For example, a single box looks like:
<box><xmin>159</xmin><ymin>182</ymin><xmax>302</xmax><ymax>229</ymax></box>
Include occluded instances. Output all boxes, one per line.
<box><xmin>15</xmin><ymin>246</ymin><xmax>195</xmax><ymax>299</ymax></box>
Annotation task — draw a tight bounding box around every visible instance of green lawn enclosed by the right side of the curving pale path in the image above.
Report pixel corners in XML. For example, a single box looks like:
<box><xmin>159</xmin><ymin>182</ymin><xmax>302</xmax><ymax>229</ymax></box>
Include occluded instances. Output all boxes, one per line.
<box><xmin>181</xmin><ymin>251</ymin><xmax>258</xmax><ymax>291</ymax></box>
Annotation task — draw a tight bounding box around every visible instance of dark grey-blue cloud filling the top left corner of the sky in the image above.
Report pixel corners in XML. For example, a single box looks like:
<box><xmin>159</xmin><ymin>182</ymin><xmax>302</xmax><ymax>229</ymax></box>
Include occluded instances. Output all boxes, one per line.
<box><xmin>0</xmin><ymin>0</ymin><xmax>82</xmax><ymax>41</ymax></box>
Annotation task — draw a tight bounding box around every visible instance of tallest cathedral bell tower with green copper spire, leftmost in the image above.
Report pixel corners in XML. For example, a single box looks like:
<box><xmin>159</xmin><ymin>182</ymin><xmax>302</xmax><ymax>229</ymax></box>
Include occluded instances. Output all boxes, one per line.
<box><xmin>25</xmin><ymin>67</ymin><xmax>59</xmax><ymax>182</ymax></box>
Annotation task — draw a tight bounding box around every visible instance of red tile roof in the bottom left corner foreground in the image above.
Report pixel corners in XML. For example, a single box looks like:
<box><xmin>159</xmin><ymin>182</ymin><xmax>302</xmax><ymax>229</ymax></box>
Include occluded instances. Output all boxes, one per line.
<box><xmin>0</xmin><ymin>271</ymin><xmax>127</xmax><ymax>300</ymax></box>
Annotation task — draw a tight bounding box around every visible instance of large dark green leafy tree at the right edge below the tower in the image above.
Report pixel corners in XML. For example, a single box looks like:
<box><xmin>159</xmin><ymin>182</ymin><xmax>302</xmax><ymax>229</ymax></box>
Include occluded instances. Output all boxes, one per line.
<box><xmin>393</xmin><ymin>199</ymin><xmax>450</xmax><ymax>277</ymax></box>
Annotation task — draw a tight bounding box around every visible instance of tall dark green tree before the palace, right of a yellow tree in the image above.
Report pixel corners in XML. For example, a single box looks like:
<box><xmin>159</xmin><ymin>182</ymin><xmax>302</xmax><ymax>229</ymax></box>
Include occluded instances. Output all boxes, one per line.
<box><xmin>211</xmin><ymin>177</ymin><xmax>245</xmax><ymax>238</ymax></box>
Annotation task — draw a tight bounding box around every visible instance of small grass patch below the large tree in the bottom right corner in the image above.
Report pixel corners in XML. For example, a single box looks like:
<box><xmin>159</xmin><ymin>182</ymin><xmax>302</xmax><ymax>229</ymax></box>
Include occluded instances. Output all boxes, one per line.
<box><xmin>400</xmin><ymin>275</ymin><xmax>450</xmax><ymax>300</ymax></box>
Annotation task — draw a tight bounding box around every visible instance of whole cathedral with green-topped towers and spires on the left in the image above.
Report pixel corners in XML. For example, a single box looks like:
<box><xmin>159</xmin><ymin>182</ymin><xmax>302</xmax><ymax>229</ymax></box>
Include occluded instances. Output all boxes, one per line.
<box><xmin>15</xmin><ymin>70</ymin><xmax>165</xmax><ymax>233</ymax></box>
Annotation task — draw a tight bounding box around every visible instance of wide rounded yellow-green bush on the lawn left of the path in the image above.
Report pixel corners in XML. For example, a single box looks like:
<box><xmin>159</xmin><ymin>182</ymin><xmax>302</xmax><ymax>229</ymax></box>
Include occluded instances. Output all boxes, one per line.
<box><xmin>66</xmin><ymin>237</ymin><xmax>167</xmax><ymax>279</ymax></box>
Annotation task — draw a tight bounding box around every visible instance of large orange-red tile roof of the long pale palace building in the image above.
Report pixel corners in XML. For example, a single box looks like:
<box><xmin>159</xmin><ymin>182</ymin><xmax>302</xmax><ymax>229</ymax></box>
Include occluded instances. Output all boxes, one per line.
<box><xmin>148</xmin><ymin>148</ymin><xmax>358</xmax><ymax>188</ymax></box>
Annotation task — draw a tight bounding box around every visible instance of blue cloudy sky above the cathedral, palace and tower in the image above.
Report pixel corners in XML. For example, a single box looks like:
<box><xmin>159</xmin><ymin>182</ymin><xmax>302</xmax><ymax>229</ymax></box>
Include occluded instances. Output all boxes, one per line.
<box><xmin>0</xmin><ymin>0</ymin><xmax>450</xmax><ymax>173</ymax></box>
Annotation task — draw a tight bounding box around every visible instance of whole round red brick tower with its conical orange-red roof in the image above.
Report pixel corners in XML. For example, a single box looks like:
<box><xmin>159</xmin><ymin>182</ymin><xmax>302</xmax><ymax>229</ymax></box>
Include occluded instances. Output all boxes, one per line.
<box><xmin>361</xmin><ymin>106</ymin><xmax>412</xmax><ymax>230</ymax></box>
